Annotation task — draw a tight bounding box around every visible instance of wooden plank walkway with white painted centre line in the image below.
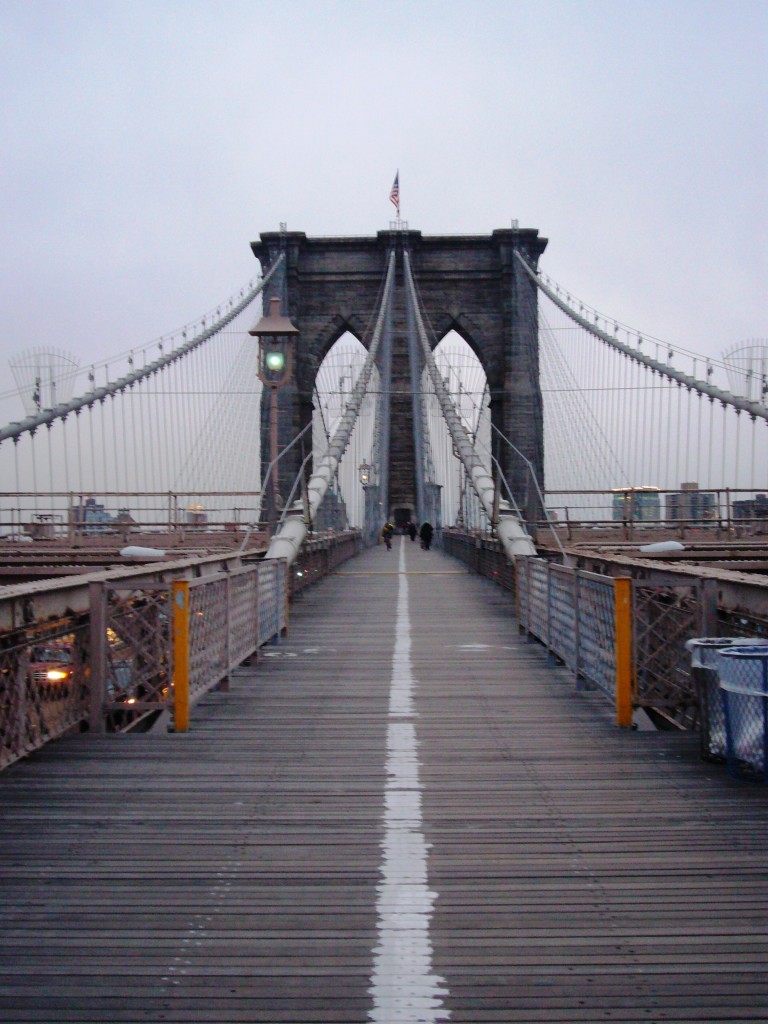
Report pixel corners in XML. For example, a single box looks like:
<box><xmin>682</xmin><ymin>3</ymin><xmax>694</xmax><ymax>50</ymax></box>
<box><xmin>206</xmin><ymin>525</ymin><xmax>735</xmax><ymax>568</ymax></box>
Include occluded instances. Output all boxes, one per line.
<box><xmin>0</xmin><ymin>540</ymin><xmax>768</xmax><ymax>1024</ymax></box>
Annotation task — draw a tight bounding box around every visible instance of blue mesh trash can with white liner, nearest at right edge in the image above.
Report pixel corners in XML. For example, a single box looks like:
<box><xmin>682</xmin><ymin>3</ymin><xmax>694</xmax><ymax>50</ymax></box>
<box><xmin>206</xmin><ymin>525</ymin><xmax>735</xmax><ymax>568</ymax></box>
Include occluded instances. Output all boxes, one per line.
<box><xmin>718</xmin><ymin>645</ymin><xmax>768</xmax><ymax>782</ymax></box>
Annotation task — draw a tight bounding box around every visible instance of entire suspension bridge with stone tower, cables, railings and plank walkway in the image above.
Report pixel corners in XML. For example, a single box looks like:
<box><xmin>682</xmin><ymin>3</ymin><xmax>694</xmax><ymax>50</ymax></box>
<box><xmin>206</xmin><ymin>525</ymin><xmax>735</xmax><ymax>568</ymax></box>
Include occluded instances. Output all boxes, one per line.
<box><xmin>0</xmin><ymin>226</ymin><xmax>768</xmax><ymax>1024</ymax></box>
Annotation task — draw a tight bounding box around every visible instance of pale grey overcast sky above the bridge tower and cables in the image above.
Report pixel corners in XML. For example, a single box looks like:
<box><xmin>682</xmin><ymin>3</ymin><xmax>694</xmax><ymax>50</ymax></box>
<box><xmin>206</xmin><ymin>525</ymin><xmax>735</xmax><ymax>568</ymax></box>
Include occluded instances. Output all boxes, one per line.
<box><xmin>0</xmin><ymin>0</ymin><xmax>768</xmax><ymax>390</ymax></box>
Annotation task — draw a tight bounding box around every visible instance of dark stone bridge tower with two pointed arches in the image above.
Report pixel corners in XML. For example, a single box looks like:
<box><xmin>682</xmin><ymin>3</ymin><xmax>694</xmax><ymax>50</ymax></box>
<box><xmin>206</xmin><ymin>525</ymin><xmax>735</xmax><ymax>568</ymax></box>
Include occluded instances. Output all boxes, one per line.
<box><xmin>251</xmin><ymin>229</ymin><xmax>547</xmax><ymax>515</ymax></box>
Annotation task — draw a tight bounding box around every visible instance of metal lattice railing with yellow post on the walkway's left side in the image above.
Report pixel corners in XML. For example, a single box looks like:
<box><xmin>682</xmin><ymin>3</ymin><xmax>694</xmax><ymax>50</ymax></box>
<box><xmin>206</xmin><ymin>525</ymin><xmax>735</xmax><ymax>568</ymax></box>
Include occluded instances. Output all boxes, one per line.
<box><xmin>0</xmin><ymin>531</ymin><xmax>360</xmax><ymax>768</ymax></box>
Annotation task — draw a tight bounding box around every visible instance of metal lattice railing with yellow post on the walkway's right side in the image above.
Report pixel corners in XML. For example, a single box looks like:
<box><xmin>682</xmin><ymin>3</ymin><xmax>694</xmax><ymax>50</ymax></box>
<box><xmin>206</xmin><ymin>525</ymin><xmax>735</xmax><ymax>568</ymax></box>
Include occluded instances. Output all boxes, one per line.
<box><xmin>443</xmin><ymin>529</ymin><xmax>768</xmax><ymax>729</ymax></box>
